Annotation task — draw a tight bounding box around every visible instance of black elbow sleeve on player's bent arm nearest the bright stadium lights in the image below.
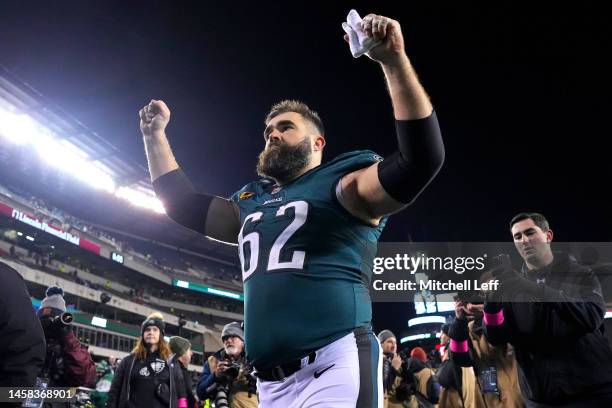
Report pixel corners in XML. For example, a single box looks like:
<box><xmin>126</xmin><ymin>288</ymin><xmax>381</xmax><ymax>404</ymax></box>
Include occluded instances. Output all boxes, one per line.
<box><xmin>153</xmin><ymin>169</ymin><xmax>213</xmax><ymax>234</ymax></box>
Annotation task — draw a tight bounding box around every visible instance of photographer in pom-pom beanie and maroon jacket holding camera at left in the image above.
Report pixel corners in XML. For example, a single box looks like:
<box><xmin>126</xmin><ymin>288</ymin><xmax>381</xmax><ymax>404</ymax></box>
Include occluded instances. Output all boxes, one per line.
<box><xmin>37</xmin><ymin>286</ymin><xmax>96</xmax><ymax>406</ymax></box>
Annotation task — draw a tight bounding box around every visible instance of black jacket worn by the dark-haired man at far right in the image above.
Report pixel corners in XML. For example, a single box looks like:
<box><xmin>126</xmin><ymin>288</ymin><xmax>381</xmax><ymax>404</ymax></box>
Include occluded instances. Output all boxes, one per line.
<box><xmin>484</xmin><ymin>255</ymin><xmax>612</xmax><ymax>406</ymax></box>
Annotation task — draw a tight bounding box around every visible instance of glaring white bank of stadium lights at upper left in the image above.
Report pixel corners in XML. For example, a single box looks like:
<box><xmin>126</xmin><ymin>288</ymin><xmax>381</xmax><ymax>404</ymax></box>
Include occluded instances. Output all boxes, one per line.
<box><xmin>0</xmin><ymin>66</ymin><xmax>164</xmax><ymax>213</ymax></box>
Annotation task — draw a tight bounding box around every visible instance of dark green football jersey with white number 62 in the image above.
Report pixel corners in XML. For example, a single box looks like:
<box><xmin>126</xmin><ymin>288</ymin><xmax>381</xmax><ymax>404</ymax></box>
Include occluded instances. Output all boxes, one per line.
<box><xmin>231</xmin><ymin>151</ymin><xmax>386</xmax><ymax>370</ymax></box>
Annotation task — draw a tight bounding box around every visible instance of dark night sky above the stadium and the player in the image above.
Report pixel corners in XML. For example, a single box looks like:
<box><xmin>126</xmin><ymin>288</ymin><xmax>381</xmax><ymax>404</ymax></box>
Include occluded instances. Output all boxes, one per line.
<box><xmin>0</xmin><ymin>1</ymin><xmax>612</xmax><ymax>342</ymax></box>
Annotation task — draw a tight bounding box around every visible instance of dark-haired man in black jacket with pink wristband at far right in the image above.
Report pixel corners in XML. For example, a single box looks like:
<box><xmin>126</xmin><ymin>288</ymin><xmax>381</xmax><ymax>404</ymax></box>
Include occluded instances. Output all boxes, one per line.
<box><xmin>484</xmin><ymin>213</ymin><xmax>612</xmax><ymax>407</ymax></box>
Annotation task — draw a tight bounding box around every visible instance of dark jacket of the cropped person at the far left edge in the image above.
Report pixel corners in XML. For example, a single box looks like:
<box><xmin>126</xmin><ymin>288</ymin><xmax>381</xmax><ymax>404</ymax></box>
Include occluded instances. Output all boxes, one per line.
<box><xmin>0</xmin><ymin>262</ymin><xmax>46</xmax><ymax>387</ymax></box>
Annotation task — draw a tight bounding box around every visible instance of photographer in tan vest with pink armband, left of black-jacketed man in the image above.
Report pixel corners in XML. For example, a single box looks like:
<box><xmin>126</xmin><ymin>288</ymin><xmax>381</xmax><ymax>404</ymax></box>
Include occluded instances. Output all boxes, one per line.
<box><xmin>449</xmin><ymin>299</ymin><xmax>525</xmax><ymax>408</ymax></box>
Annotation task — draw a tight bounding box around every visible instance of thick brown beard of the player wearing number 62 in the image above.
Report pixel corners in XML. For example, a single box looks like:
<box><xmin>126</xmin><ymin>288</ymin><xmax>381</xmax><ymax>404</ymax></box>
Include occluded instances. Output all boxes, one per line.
<box><xmin>257</xmin><ymin>137</ymin><xmax>312</xmax><ymax>184</ymax></box>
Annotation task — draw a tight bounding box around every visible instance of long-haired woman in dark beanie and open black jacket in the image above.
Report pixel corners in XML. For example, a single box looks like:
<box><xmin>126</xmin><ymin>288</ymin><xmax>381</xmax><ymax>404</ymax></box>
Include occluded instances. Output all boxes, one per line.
<box><xmin>106</xmin><ymin>313</ymin><xmax>187</xmax><ymax>408</ymax></box>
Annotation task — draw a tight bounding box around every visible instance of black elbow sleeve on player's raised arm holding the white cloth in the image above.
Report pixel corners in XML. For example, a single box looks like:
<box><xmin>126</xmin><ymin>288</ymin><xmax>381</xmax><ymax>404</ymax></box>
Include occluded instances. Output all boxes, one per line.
<box><xmin>378</xmin><ymin>112</ymin><xmax>444</xmax><ymax>204</ymax></box>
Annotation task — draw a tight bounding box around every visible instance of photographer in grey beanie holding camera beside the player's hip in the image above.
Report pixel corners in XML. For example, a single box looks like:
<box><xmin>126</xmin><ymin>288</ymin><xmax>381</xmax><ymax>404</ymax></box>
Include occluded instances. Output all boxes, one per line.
<box><xmin>197</xmin><ymin>322</ymin><xmax>258</xmax><ymax>408</ymax></box>
